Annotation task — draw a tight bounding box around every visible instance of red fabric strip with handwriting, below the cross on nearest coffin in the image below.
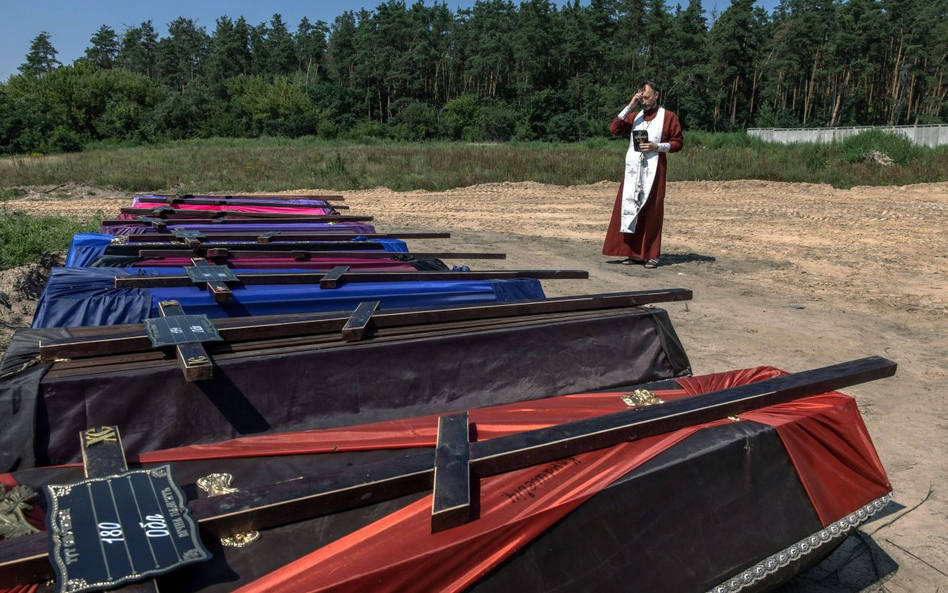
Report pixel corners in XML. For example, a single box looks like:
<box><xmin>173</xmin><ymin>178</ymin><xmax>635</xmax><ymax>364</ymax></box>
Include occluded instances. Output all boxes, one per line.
<box><xmin>238</xmin><ymin>427</ymin><xmax>716</xmax><ymax>593</ymax></box>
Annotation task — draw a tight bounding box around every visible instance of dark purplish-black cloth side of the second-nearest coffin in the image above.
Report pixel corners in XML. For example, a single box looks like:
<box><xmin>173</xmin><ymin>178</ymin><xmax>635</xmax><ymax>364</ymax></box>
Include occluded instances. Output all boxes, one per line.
<box><xmin>0</xmin><ymin>308</ymin><xmax>690</xmax><ymax>471</ymax></box>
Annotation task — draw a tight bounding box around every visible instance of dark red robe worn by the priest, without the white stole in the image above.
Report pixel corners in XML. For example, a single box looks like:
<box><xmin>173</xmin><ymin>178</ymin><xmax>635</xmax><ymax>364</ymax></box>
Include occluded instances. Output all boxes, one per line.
<box><xmin>602</xmin><ymin>109</ymin><xmax>685</xmax><ymax>260</ymax></box>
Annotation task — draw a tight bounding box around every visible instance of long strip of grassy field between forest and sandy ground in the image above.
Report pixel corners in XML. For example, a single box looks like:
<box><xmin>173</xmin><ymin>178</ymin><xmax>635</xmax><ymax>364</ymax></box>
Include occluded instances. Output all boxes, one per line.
<box><xmin>0</xmin><ymin>132</ymin><xmax>948</xmax><ymax>192</ymax></box>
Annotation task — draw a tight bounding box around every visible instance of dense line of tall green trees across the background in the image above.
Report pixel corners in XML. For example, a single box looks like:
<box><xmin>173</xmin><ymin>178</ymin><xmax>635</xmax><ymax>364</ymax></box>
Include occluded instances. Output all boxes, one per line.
<box><xmin>0</xmin><ymin>0</ymin><xmax>948</xmax><ymax>153</ymax></box>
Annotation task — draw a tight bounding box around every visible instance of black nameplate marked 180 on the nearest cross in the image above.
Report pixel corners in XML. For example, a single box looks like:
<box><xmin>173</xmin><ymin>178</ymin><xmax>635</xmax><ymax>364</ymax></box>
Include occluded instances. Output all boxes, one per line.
<box><xmin>46</xmin><ymin>465</ymin><xmax>211</xmax><ymax>593</ymax></box>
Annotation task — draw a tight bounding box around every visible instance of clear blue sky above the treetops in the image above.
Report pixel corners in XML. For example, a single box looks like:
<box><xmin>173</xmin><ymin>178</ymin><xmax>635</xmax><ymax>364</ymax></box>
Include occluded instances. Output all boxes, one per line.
<box><xmin>0</xmin><ymin>0</ymin><xmax>778</xmax><ymax>80</ymax></box>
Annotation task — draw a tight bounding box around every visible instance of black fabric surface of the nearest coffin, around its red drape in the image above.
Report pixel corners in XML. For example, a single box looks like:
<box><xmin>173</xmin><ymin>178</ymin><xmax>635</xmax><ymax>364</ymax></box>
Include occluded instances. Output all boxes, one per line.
<box><xmin>5</xmin><ymin>374</ymin><xmax>888</xmax><ymax>593</ymax></box>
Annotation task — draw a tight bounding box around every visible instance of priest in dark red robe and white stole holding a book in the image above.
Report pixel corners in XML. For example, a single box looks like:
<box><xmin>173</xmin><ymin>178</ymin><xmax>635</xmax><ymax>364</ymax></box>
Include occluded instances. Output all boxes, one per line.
<box><xmin>602</xmin><ymin>82</ymin><xmax>685</xmax><ymax>268</ymax></box>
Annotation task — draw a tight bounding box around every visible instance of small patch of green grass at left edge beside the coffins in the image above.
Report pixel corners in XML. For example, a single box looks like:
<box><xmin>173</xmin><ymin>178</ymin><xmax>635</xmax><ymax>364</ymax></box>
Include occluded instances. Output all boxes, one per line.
<box><xmin>0</xmin><ymin>208</ymin><xmax>102</xmax><ymax>270</ymax></box>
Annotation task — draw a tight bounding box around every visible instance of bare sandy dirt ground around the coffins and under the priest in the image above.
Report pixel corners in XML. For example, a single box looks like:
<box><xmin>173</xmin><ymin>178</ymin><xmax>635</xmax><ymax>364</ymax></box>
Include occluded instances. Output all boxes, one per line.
<box><xmin>0</xmin><ymin>182</ymin><xmax>948</xmax><ymax>592</ymax></box>
